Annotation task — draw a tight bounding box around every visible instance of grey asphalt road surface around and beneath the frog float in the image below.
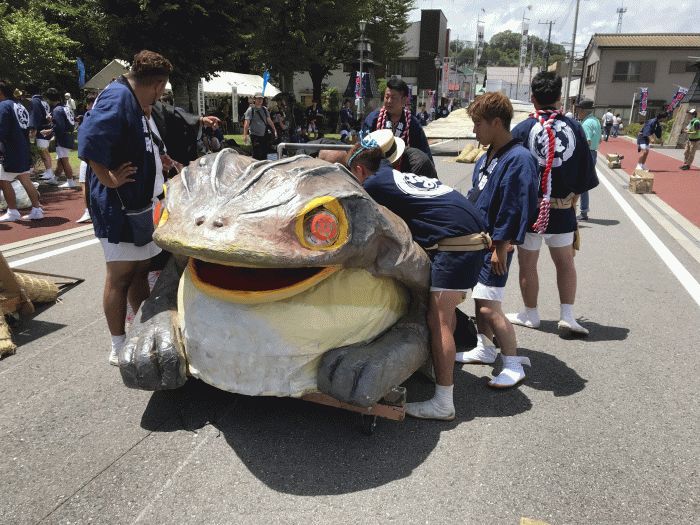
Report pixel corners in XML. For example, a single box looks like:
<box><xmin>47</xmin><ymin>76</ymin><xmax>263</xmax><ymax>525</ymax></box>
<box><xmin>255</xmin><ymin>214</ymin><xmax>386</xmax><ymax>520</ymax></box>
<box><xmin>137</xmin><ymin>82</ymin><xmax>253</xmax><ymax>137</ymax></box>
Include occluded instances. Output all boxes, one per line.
<box><xmin>0</xmin><ymin>157</ymin><xmax>700</xmax><ymax>525</ymax></box>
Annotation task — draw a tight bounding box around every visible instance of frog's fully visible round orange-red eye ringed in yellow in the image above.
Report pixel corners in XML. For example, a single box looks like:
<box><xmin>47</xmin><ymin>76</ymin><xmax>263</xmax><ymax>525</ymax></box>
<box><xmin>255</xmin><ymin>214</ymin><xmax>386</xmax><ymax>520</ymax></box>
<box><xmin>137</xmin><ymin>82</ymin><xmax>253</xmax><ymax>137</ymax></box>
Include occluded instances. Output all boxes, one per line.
<box><xmin>296</xmin><ymin>196</ymin><xmax>348</xmax><ymax>250</ymax></box>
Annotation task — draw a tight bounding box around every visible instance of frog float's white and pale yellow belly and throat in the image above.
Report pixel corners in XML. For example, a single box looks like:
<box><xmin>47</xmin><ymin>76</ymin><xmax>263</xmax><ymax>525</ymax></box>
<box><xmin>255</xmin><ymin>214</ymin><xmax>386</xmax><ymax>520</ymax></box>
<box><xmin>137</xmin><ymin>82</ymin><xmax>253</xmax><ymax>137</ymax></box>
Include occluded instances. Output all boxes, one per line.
<box><xmin>178</xmin><ymin>268</ymin><xmax>409</xmax><ymax>396</ymax></box>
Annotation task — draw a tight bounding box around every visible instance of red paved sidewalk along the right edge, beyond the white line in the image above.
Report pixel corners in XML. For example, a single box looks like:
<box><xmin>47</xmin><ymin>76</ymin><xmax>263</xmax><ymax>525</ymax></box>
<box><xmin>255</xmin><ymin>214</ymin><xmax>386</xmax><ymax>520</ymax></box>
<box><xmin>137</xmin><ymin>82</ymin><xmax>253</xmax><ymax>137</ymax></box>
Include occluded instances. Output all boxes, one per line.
<box><xmin>598</xmin><ymin>138</ymin><xmax>700</xmax><ymax>226</ymax></box>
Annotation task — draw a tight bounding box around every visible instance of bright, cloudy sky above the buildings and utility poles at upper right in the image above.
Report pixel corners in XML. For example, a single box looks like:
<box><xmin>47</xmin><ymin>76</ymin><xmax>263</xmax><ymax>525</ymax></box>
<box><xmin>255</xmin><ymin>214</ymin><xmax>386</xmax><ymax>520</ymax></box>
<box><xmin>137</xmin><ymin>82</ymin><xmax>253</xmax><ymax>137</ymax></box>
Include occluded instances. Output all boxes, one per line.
<box><xmin>411</xmin><ymin>0</ymin><xmax>700</xmax><ymax>52</ymax></box>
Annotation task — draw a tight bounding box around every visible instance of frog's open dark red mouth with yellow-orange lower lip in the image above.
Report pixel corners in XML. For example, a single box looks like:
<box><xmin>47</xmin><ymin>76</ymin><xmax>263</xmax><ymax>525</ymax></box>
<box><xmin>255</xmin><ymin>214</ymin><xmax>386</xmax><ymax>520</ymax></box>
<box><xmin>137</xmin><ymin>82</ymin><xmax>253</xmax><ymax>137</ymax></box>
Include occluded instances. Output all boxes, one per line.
<box><xmin>188</xmin><ymin>258</ymin><xmax>339</xmax><ymax>303</ymax></box>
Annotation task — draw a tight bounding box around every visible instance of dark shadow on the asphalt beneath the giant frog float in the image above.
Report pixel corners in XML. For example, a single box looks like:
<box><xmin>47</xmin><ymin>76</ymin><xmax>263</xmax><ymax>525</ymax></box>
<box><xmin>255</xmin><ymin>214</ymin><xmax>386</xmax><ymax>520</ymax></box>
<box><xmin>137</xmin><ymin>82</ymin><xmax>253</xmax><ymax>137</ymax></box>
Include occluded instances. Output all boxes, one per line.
<box><xmin>141</xmin><ymin>370</ymin><xmax>532</xmax><ymax>496</ymax></box>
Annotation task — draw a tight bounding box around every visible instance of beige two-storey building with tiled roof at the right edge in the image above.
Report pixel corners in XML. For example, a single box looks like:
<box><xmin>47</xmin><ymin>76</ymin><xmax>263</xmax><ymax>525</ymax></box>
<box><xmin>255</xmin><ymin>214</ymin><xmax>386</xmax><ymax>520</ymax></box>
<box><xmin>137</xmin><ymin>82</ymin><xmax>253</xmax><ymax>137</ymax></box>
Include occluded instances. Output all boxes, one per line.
<box><xmin>581</xmin><ymin>33</ymin><xmax>700</xmax><ymax>121</ymax></box>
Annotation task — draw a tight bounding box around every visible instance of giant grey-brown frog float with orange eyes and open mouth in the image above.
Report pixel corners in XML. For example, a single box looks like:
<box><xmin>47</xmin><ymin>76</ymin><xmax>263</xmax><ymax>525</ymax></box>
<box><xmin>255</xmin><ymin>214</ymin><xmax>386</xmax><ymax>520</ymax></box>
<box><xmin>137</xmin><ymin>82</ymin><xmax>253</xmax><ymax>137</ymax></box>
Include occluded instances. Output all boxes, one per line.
<box><xmin>119</xmin><ymin>150</ymin><xmax>430</xmax><ymax>407</ymax></box>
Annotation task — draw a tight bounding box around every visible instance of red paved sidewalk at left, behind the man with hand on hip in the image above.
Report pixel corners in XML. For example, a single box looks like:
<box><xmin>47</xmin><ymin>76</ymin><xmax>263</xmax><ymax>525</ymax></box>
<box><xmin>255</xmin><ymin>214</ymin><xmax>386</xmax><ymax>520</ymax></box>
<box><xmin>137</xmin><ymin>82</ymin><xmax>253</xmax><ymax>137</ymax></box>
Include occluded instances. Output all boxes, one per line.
<box><xmin>0</xmin><ymin>186</ymin><xmax>85</xmax><ymax>245</ymax></box>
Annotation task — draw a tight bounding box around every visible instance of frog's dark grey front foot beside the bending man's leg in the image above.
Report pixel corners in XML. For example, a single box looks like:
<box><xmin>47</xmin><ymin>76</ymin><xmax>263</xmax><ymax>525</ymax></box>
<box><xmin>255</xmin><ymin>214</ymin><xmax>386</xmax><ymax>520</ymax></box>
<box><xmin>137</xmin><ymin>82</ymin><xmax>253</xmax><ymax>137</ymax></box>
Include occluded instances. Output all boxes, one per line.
<box><xmin>317</xmin><ymin>314</ymin><xmax>429</xmax><ymax>407</ymax></box>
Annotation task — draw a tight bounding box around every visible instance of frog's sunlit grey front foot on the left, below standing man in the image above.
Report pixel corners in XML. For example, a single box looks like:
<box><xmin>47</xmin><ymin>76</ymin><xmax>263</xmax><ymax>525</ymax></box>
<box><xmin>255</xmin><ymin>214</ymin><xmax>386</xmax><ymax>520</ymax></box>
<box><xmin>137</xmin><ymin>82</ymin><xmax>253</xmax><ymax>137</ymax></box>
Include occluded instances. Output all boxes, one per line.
<box><xmin>119</xmin><ymin>310</ymin><xmax>187</xmax><ymax>390</ymax></box>
